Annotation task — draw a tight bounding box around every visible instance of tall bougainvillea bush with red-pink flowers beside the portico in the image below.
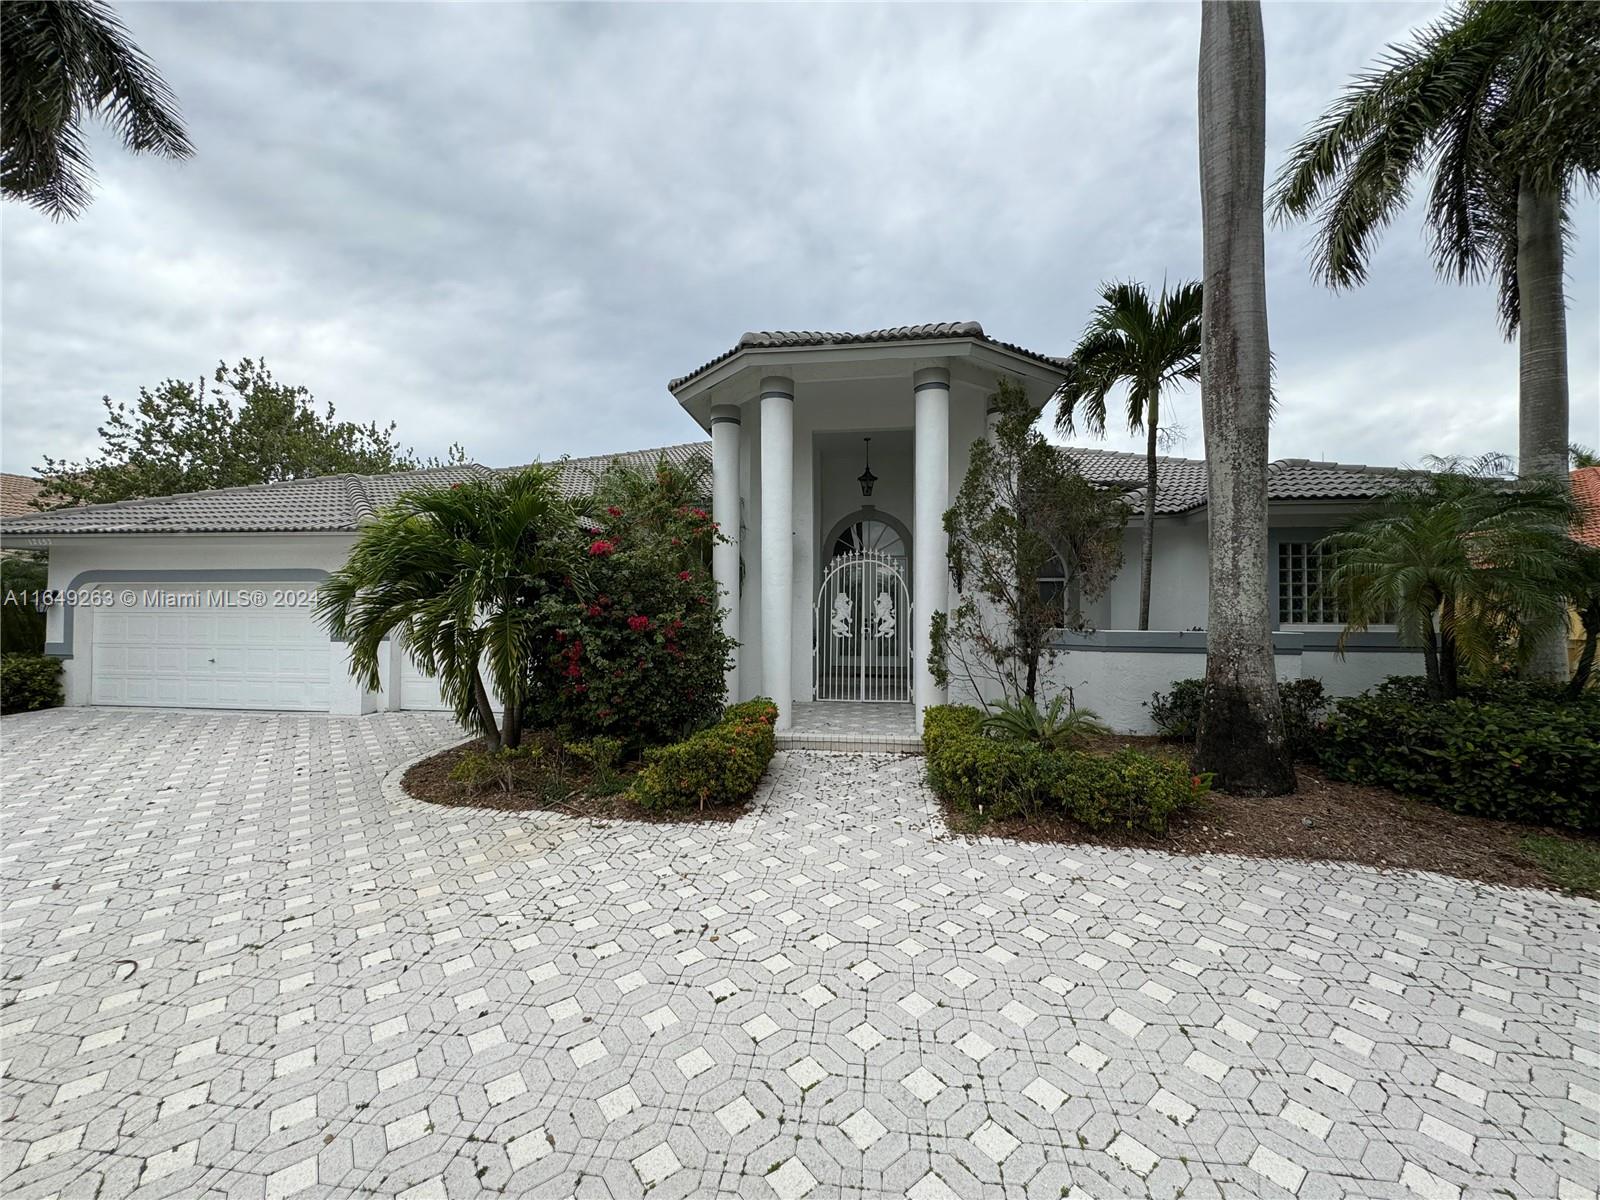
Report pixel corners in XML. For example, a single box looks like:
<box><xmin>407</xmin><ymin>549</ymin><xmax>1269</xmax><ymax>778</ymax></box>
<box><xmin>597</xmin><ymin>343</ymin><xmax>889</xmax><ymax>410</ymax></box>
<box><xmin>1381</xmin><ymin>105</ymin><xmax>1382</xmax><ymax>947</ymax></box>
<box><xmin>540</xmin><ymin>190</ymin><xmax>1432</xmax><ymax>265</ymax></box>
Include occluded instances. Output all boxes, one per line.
<box><xmin>530</xmin><ymin>464</ymin><xmax>734</xmax><ymax>750</ymax></box>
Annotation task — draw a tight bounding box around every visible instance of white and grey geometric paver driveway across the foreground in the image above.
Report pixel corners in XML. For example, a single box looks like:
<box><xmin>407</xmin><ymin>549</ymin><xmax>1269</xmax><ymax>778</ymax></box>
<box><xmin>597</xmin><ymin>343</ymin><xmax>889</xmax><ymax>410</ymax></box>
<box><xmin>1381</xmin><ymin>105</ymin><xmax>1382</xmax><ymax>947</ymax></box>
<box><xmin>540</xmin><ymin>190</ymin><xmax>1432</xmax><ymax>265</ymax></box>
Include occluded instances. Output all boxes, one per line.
<box><xmin>0</xmin><ymin>710</ymin><xmax>1600</xmax><ymax>1200</ymax></box>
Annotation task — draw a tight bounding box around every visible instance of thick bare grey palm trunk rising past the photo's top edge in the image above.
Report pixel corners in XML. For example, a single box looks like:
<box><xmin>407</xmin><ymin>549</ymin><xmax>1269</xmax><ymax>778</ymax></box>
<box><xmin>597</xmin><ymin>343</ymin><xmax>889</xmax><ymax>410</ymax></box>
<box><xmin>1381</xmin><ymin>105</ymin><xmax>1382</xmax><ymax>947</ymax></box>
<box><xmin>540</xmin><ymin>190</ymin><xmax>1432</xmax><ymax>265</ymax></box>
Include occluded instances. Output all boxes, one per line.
<box><xmin>1195</xmin><ymin>0</ymin><xmax>1294</xmax><ymax>795</ymax></box>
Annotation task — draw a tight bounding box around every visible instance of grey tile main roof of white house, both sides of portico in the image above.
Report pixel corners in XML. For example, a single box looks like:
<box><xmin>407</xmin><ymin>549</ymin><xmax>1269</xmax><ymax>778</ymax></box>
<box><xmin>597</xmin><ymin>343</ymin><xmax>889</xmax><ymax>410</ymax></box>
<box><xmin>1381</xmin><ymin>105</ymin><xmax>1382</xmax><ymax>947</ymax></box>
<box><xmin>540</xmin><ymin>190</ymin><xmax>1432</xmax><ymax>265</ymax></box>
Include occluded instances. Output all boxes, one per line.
<box><xmin>0</xmin><ymin>442</ymin><xmax>1420</xmax><ymax>536</ymax></box>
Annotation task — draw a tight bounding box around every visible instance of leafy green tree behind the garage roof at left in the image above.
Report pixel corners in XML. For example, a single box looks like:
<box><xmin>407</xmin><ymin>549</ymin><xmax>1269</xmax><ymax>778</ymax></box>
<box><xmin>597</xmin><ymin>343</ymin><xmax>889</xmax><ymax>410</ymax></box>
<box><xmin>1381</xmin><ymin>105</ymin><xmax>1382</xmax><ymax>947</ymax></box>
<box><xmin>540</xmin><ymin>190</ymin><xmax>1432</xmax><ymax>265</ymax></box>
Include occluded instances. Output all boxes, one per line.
<box><xmin>38</xmin><ymin>358</ymin><xmax>466</xmax><ymax>507</ymax></box>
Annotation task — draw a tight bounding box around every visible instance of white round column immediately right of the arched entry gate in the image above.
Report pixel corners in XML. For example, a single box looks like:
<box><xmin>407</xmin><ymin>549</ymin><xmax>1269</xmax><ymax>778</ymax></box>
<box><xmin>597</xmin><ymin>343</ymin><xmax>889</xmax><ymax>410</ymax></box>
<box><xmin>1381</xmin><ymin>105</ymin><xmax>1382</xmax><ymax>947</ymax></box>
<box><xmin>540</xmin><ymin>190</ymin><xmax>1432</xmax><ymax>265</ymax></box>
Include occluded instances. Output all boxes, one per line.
<box><xmin>910</xmin><ymin>366</ymin><xmax>950</xmax><ymax>730</ymax></box>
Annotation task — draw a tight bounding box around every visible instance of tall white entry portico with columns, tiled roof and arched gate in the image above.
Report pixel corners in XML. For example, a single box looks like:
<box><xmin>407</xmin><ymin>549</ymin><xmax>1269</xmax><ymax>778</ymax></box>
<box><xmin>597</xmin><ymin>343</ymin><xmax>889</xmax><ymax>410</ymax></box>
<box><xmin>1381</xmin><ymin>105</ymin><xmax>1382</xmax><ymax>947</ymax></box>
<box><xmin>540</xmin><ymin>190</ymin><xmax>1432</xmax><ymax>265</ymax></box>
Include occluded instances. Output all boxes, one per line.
<box><xmin>669</xmin><ymin>322</ymin><xmax>1064</xmax><ymax>728</ymax></box>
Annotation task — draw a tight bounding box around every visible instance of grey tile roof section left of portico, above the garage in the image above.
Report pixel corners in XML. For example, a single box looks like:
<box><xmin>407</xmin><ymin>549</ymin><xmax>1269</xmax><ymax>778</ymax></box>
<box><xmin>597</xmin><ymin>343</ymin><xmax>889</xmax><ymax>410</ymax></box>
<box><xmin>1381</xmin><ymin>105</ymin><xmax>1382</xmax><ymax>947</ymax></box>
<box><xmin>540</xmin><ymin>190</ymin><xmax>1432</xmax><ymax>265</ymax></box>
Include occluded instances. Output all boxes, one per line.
<box><xmin>0</xmin><ymin>442</ymin><xmax>710</xmax><ymax>536</ymax></box>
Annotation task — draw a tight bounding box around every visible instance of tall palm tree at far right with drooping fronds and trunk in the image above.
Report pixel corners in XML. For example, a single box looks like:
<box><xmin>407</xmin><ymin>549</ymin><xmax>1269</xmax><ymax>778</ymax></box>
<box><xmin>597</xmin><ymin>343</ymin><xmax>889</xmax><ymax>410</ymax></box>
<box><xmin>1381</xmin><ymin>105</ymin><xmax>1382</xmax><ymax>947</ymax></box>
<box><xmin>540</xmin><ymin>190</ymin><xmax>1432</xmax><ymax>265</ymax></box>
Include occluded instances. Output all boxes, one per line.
<box><xmin>1274</xmin><ymin>0</ymin><xmax>1600</xmax><ymax>678</ymax></box>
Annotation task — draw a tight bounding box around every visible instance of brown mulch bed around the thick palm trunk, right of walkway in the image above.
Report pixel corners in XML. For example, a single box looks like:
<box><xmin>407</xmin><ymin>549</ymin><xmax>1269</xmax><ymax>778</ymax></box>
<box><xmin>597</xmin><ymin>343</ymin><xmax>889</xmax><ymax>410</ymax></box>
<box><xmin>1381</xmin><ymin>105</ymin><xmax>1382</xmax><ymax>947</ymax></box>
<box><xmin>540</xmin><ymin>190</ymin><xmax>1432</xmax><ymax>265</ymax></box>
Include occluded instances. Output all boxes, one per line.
<box><xmin>944</xmin><ymin>736</ymin><xmax>1597</xmax><ymax>888</ymax></box>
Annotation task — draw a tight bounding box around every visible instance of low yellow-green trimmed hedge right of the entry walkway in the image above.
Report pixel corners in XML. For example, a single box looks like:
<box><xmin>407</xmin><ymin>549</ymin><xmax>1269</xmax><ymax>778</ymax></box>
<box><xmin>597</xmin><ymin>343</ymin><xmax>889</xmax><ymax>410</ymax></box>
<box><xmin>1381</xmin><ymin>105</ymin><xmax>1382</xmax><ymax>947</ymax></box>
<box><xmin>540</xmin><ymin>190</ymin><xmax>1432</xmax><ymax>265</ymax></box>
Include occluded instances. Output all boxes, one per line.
<box><xmin>922</xmin><ymin>704</ymin><xmax>1211</xmax><ymax>834</ymax></box>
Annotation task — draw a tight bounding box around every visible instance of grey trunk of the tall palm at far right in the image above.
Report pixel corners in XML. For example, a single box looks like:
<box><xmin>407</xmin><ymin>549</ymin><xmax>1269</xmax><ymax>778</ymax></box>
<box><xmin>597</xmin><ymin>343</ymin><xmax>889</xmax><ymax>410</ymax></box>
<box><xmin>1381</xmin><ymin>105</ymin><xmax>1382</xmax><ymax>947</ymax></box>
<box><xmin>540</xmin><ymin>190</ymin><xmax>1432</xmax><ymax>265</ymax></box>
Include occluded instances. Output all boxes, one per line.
<box><xmin>1517</xmin><ymin>179</ymin><xmax>1570</xmax><ymax>683</ymax></box>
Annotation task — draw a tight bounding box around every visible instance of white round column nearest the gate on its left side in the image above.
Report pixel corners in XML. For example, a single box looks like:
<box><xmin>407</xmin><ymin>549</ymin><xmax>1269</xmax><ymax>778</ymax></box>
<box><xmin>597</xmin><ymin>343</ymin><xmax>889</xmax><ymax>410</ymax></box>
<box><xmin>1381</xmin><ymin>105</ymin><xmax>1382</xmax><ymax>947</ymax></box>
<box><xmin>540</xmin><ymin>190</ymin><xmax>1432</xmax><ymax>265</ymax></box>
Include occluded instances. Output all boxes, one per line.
<box><xmin>762</xmin><ymin>376</ymin><xmax>795</xmax><ymax>730</ymax></box>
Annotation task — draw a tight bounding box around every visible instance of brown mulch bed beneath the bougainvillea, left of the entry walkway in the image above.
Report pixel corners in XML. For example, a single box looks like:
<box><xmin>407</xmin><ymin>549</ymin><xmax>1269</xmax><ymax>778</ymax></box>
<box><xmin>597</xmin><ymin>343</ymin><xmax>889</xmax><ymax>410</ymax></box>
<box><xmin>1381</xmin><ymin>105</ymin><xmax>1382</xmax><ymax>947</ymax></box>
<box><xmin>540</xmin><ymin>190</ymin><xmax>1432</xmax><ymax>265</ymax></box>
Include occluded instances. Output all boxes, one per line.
<box><xmin>400</xmin><ymin>741</ymin><xmax>749</xmax><ymax>824</ymax></box>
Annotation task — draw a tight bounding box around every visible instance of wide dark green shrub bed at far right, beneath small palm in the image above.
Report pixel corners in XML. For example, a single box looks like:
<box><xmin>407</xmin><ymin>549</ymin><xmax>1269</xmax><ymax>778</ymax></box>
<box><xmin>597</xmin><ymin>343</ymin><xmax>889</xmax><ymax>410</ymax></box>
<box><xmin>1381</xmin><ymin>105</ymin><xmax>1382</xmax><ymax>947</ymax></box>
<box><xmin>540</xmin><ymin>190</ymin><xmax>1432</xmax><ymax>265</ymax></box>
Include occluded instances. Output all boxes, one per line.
<box><xmin>1318</xmin><ymin>691</ymin><xmax>1600</xmax><ymax>832</ymax></box>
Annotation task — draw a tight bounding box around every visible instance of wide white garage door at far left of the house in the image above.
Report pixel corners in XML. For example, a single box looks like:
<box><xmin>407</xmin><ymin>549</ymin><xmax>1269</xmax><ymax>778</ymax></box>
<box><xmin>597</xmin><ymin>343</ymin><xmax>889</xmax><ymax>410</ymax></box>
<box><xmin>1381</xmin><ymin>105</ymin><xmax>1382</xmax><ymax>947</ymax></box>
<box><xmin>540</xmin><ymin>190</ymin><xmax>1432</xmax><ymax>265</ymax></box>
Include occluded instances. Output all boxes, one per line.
<box><xmin>90</xmin><ymin>584</ymin><xmax>330</xmax><ymax>712</ymax></box>
